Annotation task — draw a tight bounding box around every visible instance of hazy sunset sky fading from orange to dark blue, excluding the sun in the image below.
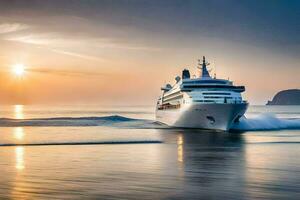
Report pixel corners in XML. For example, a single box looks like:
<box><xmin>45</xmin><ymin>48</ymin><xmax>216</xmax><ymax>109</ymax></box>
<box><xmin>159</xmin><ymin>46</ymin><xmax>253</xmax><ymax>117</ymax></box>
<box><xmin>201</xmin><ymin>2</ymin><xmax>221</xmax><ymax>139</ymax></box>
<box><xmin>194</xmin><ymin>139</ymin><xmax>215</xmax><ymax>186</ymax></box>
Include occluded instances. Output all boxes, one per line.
<box><xmin>0</xmin><ymin>0</ymin><xmax>300</xmax><ymax>105</ymax></box>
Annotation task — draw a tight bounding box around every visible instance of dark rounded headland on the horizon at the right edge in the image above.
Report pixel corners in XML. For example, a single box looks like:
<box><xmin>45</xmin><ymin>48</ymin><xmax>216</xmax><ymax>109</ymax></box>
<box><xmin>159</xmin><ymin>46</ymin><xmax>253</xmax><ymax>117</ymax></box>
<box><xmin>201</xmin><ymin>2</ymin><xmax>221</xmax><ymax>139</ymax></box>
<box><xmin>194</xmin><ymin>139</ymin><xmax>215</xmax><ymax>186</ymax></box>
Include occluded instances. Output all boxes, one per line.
<box><xmin>267</xmin><ymin>89</ymin><xmax>300</xmax><ymax>105</ymax></box>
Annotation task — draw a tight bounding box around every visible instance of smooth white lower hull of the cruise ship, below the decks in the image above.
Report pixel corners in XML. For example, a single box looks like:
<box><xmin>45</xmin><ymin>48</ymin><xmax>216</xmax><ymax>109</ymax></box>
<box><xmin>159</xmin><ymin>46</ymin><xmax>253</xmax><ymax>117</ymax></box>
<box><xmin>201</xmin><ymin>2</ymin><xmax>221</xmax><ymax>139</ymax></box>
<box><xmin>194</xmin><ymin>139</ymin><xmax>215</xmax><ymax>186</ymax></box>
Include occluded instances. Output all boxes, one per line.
<box><xmin>156</xmin><ymin>103</ymin><xmax>248</xmax><ymax>131</ymax></box>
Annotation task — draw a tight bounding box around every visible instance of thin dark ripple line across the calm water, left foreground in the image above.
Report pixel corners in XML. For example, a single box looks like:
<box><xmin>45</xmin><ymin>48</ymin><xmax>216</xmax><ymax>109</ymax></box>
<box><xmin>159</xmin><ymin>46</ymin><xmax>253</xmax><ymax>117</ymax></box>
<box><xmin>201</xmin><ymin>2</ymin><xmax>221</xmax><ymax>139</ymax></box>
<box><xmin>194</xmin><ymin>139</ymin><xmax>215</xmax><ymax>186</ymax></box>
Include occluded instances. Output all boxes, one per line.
<box><xmin>0</xmin><ymin>140</ymin><xmax>163</xmax><ymax>147</ymax></box>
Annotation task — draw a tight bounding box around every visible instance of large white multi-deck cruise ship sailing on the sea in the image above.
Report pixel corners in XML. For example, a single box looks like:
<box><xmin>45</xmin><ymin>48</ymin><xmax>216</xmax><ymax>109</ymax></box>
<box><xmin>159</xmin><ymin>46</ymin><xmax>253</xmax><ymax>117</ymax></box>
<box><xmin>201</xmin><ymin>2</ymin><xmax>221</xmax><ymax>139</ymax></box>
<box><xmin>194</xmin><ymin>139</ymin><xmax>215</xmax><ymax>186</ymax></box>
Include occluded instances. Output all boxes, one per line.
<box><xmin>156</xmin><ymin>56</ymin><xmax>248</xmax><ymax>131</ymax></box>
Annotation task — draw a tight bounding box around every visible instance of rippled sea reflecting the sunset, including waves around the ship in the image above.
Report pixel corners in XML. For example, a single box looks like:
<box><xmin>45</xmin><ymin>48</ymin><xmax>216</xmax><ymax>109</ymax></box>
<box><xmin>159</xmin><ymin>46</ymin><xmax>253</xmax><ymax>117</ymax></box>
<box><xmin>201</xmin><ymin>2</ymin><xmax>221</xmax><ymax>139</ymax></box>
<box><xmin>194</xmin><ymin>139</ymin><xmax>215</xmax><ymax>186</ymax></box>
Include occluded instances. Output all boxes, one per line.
<box><xmin>0</xmin><ymin>105</ymin><xmax>300</xmax><ymax>200</ymax></box>
